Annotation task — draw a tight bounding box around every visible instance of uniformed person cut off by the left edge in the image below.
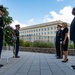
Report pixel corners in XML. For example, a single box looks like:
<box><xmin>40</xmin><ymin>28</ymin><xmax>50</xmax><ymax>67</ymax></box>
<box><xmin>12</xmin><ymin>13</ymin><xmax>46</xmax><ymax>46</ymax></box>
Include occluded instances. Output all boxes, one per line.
<box><xmin>0</xmin><ymin>6</ymin><xmax>4</xmax><ymax>67</ymax></box>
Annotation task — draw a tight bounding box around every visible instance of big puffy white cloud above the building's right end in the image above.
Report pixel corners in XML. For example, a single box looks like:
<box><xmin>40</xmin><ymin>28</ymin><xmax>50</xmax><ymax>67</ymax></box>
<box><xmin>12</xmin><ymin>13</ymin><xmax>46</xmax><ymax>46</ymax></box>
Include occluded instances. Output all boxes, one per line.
<box><xmin>43</xmin><ymin>6</ymin><xmax>73</xmax><ymax>23</ymax></box>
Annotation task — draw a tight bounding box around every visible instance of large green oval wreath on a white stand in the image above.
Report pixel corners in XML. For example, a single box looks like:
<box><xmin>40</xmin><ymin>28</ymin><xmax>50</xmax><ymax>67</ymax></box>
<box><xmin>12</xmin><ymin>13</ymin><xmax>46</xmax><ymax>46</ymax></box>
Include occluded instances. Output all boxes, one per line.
<box><xmin>4</xmin><ymin>26</ymin><xmax>16</xmax><ymax>46</ymax></box>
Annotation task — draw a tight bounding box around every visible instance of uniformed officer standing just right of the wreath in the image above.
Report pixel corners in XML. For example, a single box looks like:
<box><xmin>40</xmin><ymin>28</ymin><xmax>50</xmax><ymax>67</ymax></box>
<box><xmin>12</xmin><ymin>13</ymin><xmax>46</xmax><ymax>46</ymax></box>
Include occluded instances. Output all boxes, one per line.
<box><xmin>15</xmin><ymin>24</ymin><xmax>20</xmax><ymax>58</ymax></box>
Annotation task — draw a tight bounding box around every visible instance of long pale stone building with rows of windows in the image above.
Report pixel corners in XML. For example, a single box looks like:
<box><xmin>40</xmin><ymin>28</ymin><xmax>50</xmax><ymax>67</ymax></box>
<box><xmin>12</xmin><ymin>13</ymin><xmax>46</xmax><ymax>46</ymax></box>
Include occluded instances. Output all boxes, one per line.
<box><xmin>20</xmin><ymin>21</ymin><xmax>69</xmax><ymax>42</ymax></box>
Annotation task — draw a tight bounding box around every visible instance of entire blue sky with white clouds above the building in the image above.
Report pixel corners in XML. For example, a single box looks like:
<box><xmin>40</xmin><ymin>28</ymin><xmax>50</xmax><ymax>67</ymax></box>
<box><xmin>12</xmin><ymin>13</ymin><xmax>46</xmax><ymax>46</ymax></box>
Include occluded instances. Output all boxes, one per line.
<box><xmin>0</xmin><ymin>0</ymin><xmax>75</xmax><ymax>27</ymax></box>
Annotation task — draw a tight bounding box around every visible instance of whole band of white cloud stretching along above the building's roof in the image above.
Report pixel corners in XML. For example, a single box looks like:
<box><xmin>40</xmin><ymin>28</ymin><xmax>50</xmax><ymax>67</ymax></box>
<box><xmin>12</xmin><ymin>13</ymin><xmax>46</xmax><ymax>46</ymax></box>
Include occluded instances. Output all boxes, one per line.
<box><xmin>11</xmin><ymin>6</ymin><xmax>74</xmax><ymax>28</ymax></box>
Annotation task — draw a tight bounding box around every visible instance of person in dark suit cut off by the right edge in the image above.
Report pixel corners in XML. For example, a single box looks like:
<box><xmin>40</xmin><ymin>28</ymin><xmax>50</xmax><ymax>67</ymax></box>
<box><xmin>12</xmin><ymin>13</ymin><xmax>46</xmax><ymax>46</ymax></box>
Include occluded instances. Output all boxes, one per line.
<box><xmin>70</xmin><ymin>7</ymin><xmax>75</xmax><ymax>69</ymax></box>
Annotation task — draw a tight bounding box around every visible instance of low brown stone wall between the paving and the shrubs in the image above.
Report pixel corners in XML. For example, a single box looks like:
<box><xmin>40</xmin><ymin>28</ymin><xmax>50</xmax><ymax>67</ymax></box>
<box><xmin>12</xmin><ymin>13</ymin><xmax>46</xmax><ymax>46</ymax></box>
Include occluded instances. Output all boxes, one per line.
<box><xmin>3</xmin><ymin>47</ymin><xmax>75</xmax><ymax>56</ymax></box>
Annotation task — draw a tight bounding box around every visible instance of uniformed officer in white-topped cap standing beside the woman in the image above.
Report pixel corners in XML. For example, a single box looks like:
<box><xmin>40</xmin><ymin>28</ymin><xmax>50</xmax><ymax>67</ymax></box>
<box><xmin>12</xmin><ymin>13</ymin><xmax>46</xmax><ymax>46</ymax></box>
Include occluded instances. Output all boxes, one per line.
<box><xmin>56</xmin><ymin>25</ymin><xmax>62</xmax><ymax>59</ymax></box>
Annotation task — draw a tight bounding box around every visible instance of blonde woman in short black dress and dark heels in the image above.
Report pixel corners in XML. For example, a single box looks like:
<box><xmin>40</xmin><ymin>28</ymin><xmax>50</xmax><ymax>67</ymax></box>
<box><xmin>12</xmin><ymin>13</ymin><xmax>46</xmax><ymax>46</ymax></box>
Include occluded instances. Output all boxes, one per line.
<box><xmin>62</xmin><ymin>22</ymin><xmax>68</xmax><ymax>62</ymax></box>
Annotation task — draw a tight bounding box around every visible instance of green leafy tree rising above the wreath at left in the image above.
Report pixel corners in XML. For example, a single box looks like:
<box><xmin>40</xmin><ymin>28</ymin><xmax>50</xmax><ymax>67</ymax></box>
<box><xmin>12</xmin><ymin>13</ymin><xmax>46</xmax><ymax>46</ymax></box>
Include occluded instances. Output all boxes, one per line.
<box><xmin>0</xmin><ymin>5</ymin><xmax>13</xmax><ymax>26</ymax></box>
